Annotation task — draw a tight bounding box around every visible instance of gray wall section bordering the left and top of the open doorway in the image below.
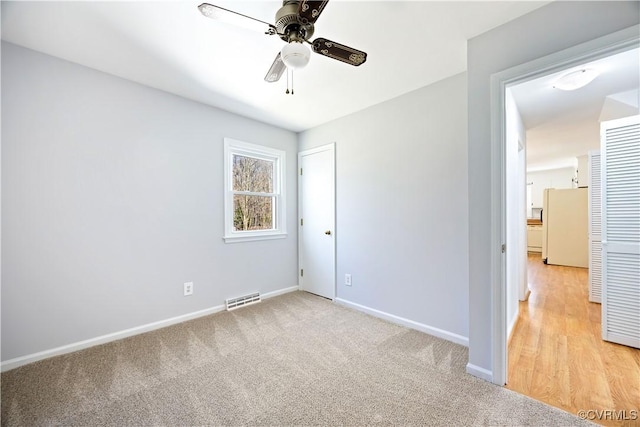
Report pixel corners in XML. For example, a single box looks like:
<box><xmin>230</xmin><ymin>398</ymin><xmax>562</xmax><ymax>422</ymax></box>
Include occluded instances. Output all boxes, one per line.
<box><xmin>467</xmin><ymin>1</ymin><xmax>640</xmax><ymax>371</ymax></box>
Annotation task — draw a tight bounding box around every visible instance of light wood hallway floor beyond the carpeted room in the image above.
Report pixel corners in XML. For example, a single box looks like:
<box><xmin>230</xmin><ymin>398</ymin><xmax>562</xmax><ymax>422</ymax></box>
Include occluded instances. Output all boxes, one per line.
<box><xmin>507</xmin><ymin>253</ymin><xmax>640</xmax><ymax>426</ymax></box>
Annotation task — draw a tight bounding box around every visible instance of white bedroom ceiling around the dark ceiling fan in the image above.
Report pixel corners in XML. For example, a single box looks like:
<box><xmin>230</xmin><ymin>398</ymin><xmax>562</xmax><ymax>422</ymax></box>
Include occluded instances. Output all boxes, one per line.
<box><xmin>2</xmin><ymin>0</ymin><xmax>549</xmax><ymax>131</ymax></box>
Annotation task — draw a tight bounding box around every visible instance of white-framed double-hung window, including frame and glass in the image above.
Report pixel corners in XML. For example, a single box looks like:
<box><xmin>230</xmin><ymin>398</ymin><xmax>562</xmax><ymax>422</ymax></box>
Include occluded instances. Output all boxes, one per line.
<box><xmin>224</xmin><ymin>138</ymin><xmax>287</xmax><ymax>243</ymax></box>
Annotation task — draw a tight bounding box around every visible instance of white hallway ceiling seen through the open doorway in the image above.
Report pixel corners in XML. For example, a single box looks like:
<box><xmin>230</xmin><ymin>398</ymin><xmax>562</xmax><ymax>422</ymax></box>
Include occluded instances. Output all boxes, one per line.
<box><xmin>511</xmin><ymin>49</ymin><xmax>640</xmax><ymax>172</ymax></box>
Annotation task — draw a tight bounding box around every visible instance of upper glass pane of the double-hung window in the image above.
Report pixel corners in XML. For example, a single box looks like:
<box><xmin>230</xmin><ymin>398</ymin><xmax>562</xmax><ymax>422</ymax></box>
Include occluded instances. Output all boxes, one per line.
<box><xmin>233</xmin><ymin>154</ymin><xmax>273</xmax><ymax>193</ymax></box>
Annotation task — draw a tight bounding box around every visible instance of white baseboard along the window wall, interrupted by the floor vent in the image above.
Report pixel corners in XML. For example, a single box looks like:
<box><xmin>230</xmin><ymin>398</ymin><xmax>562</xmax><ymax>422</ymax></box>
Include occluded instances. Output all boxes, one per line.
<box><xmin>0</xmin><ymin>286</ymin><xmax>298</xmax><ymax>372</ymax></box>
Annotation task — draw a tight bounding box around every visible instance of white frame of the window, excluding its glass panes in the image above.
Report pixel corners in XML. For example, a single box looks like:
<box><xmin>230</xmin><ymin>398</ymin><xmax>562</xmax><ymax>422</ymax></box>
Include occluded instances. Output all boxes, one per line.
<box><xmin>223</xmin><ymin>138</ymin><xmax>287</xmax><ymax>243</ymax></box>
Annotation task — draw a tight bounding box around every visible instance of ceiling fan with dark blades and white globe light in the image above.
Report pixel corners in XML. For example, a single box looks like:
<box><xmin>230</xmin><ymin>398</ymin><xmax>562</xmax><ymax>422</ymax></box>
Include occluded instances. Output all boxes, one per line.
<box><xmin>198</xmin><ymin>0</ymin><xmax>367</xmax><ymax>83</ymax></box>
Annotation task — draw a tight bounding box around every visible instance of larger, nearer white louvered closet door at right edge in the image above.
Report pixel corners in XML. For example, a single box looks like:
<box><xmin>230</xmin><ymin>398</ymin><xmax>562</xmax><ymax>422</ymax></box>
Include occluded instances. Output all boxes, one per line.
<box><xmin>601</xmin><ymin>116</ymin><xmax>640</xmax><ymax>348</ymax></box>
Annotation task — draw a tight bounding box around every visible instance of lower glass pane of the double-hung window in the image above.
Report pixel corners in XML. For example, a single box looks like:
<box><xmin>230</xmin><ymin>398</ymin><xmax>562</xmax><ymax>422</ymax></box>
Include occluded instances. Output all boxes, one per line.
<box><xmin>233</xmin><ymin>195</ymin><xmax>274</xmax><ymax>231</ymax></box>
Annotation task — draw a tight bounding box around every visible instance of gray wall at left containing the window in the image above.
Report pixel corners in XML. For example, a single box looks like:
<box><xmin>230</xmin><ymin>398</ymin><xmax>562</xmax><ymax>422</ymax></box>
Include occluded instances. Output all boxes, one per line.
<box><xmin>2</xmin><ymin>43</ymin><xmax>297</xmax><ymax>361</ymax></box>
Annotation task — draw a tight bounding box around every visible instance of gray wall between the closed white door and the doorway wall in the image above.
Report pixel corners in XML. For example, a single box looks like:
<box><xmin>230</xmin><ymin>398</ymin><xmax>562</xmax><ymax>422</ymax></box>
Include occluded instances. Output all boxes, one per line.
<box><xmin>299</xmin><ymin>74</ymin><xmax>469</xmax><ymax>338</ymax></box>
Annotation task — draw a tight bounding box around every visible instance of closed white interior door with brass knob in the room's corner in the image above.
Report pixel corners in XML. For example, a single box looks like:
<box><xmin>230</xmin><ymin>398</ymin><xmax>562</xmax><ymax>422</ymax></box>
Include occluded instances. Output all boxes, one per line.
<box><xmin>298</xmin><ymin>144</ymin><xmax>336</xmax><ymax>299</ymax></box>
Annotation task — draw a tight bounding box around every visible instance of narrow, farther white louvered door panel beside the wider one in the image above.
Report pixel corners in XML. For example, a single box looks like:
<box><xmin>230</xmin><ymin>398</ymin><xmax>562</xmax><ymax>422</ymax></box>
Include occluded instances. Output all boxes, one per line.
<box><xmin>589</xmin><ymin>150</ymin><xmax>602</xmax><ymax>302</ymax></box>
